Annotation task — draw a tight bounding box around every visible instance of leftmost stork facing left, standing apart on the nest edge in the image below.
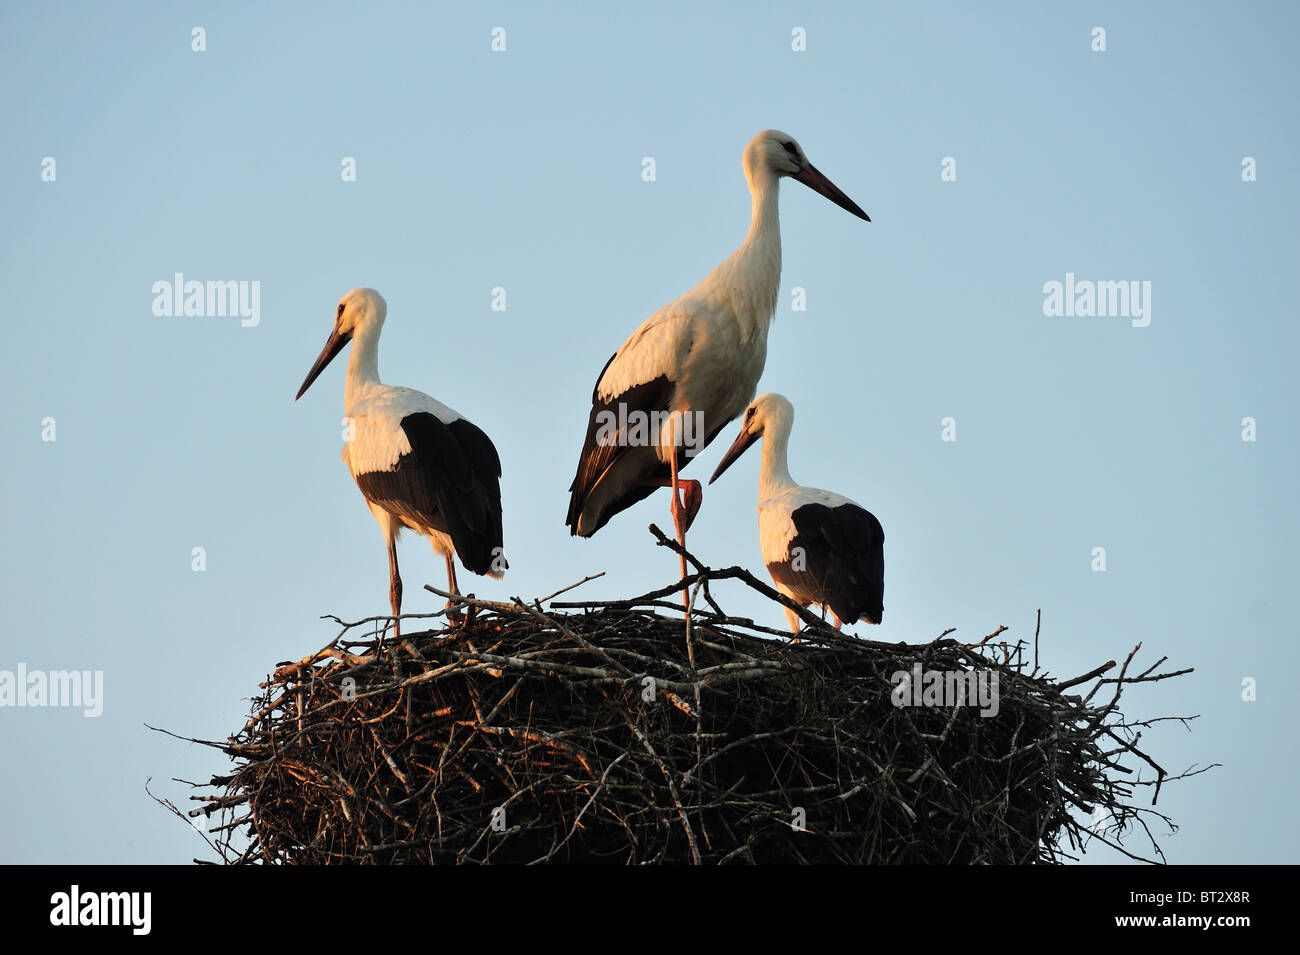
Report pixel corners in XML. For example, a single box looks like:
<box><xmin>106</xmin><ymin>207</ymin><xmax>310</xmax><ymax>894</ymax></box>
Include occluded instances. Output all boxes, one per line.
<box><xmin>294</xmin><ymin>288</ymin><xmax>508</xmax><ymax>635</ymax></box>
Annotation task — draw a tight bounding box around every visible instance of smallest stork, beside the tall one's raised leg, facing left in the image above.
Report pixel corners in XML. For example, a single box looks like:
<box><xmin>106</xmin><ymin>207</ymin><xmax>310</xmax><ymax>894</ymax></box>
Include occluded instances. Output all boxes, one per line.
<box><xmin>709</xmin><ymin>392</ymin><xmax>885</xmax><ymax>634</ymax></box>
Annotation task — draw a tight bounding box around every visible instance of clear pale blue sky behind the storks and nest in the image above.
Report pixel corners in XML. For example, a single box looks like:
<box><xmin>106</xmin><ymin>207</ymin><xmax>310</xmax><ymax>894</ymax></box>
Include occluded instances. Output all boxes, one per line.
<box><xmin>0</xmin><ymin>3</ymin><xmax>1300</xmax><ymax>863</ymax></box>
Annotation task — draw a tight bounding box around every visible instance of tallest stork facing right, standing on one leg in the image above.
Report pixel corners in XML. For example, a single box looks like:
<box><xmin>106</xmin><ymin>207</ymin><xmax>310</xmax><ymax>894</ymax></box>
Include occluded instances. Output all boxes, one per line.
<box><xmin>566</xmin><ymin>130</ymin><xmax>871</xmax><ymax>603</ymax></box>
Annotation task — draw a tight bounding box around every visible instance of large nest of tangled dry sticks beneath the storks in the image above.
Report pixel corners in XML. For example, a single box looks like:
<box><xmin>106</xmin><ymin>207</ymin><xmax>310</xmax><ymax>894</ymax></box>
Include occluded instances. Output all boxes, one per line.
<box><xmin>170</xmin><ymin>530</ymin><xmax>1206</xmax><ymax>864</ymax></box>
